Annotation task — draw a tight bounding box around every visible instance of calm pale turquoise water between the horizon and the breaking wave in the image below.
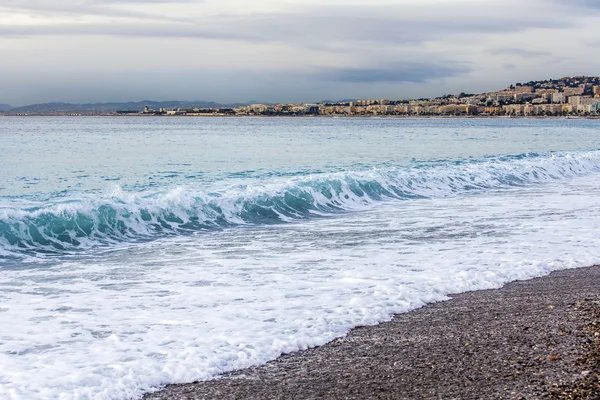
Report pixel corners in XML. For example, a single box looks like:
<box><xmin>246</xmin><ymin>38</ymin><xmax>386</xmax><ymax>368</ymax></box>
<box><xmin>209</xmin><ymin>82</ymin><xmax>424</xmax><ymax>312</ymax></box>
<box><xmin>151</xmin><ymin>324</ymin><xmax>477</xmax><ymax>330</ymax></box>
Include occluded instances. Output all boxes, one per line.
<box><xmin>0</xmin><ymin>117</ymin><xmax>600</xmax><ymax>199</ymax></box>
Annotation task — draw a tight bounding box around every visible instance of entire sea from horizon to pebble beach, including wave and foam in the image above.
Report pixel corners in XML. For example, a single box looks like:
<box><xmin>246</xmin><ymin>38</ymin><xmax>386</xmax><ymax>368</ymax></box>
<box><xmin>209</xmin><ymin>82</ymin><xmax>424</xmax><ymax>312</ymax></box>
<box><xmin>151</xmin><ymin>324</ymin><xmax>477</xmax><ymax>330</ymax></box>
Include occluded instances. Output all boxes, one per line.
<box><xmin>0</xmin><ymin>117</ymin><xmax>600</xmax><ymax>400</ymax></box>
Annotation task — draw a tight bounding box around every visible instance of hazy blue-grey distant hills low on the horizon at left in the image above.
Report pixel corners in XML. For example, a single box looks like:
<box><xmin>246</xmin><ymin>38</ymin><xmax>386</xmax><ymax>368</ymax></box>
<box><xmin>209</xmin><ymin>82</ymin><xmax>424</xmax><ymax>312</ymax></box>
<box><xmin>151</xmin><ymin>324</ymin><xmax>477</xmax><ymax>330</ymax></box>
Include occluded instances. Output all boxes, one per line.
<box><xmin>5</xmin><ymin>100</ymin><xmax>255</xmax><ymax>115</ymax></box>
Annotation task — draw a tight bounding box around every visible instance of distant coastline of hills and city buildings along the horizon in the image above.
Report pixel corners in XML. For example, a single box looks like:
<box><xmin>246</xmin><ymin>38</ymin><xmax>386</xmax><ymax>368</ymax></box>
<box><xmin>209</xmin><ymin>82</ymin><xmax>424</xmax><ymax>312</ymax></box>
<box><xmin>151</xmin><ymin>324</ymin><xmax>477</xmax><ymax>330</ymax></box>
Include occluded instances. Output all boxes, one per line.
<box><xmin>8</xmin><ymin>76</ymin><xmax>600</xmax><ymax>118</ymax></box>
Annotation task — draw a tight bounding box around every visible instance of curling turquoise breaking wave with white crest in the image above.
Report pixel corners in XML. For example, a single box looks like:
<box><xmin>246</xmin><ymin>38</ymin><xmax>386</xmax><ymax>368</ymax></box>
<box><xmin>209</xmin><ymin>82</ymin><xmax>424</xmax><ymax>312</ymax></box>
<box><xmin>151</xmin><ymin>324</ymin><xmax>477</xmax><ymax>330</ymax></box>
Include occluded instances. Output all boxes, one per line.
<box><xmin>0</xmin><ymin>151</ymin><xmax>600</xmax><ymax>258</ymax></box>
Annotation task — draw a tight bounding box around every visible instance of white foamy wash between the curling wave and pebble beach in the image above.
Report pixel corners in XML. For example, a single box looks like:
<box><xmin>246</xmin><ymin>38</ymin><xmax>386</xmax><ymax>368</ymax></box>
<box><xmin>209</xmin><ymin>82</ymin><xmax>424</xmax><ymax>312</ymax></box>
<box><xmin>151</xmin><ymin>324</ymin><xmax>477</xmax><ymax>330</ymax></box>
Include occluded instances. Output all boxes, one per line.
<box><xmin>0</xmin><ymin>174</ymin><xmax>600</xmax><ymax>399</ymax></box>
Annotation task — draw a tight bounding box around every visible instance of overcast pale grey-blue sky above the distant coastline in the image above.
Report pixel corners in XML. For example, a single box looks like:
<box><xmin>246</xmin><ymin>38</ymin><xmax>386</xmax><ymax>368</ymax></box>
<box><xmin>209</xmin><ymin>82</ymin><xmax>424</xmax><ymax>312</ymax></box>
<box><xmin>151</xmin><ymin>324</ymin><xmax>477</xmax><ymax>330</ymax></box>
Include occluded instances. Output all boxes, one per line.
<box><xmin>0</xmin><ymin>0</ymin><xmax>600</xmax><ymax>106</ymax></box>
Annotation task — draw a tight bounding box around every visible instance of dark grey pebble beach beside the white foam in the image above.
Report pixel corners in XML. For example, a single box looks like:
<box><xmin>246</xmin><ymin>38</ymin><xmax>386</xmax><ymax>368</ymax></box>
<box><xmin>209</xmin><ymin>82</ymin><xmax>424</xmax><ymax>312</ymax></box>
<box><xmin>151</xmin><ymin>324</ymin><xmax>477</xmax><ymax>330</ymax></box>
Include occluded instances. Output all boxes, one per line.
<box><xmin>144</xmin><ymin>266</ymin><xmax>600</xmax><ymax>400</ymax></box>
